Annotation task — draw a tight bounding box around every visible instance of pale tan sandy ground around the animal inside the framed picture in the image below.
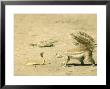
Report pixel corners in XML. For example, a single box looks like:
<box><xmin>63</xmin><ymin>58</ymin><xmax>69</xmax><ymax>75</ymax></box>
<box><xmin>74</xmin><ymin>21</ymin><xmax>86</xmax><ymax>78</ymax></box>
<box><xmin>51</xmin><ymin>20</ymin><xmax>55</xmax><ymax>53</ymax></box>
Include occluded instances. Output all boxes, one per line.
<box><xmin>14</xmin><ymin>14</ymin><xmax>97</xmax><ymax>76</ymax></box>
